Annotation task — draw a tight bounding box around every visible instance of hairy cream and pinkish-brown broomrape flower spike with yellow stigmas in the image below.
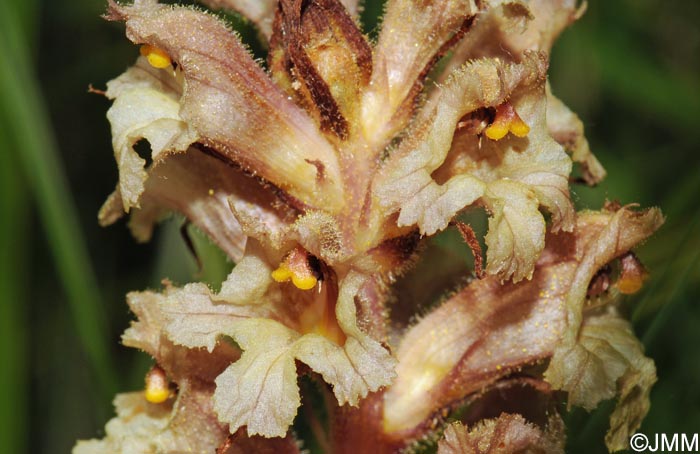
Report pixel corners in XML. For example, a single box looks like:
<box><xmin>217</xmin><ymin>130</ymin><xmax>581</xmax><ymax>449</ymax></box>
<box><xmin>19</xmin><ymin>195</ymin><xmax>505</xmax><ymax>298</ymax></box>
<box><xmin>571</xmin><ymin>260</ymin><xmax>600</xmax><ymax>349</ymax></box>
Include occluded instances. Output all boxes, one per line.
<box><xmin>74</xmin><ymin>0</ymin><xmax>663</xmax><ymax>453</ymax></box>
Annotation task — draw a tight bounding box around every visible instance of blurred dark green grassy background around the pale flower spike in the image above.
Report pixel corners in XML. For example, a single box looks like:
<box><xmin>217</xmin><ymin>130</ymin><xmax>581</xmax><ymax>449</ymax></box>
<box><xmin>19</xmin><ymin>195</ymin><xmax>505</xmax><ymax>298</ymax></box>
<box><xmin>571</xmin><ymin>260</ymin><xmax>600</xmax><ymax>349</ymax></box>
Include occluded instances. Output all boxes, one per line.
<box><xmin>0</xmin><ymin>0</ymin><xmax>700</xmax><ymax>453</ymax></box>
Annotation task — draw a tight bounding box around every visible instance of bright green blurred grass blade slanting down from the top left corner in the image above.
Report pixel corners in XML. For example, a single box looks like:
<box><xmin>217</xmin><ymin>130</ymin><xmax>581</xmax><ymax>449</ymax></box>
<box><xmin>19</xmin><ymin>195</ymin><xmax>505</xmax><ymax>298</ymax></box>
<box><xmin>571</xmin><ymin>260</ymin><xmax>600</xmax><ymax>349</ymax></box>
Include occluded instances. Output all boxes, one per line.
<box><xmin>0</xmin><ymin>1</ymin><xmax>117</xmax><ymax>395</ymax></box>
